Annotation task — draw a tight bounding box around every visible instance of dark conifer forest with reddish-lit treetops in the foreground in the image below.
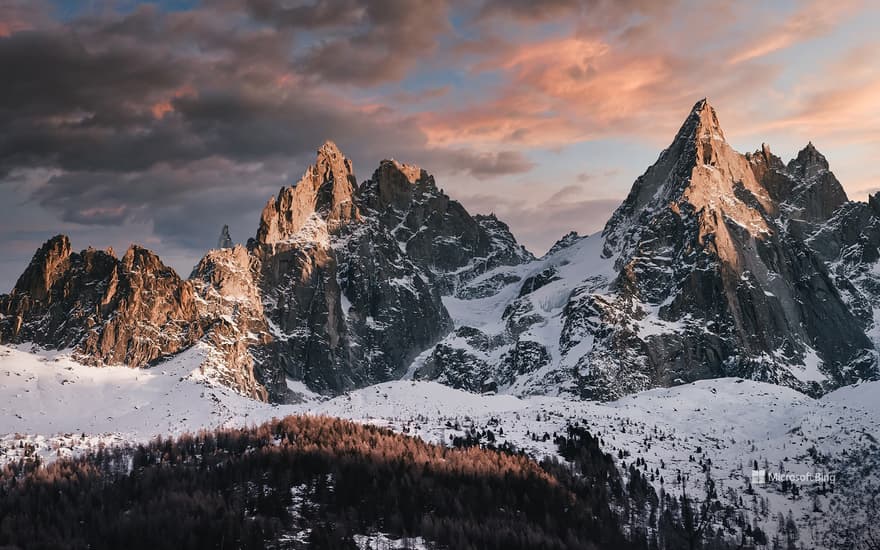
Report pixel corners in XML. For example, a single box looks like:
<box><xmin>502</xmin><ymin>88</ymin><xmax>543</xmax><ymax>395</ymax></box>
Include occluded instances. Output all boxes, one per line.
<box><xmin>0</xmin><ymin>416</ymin><xmax>748</xmax><ymax>550</ymax></box>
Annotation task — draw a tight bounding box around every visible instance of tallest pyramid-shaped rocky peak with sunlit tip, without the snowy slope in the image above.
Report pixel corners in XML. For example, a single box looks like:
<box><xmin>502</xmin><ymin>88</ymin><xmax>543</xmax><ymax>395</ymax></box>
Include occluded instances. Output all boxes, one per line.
<box><xmin>588</xmin><ymin>101</ymin><xmax>872</xmax><ymax>398</ymax></box>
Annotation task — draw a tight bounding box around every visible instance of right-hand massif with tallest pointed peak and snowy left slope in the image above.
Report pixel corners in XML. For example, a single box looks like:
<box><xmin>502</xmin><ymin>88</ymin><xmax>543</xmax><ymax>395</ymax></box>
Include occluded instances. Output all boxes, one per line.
<box><xmin>417</xmin><ymin>100</ymin><xmax>880</xmax><ymax>399</ymax></box>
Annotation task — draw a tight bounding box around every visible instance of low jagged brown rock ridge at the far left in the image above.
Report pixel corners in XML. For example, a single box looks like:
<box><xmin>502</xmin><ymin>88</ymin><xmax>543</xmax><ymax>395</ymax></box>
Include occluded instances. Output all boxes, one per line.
<box><xmin>0</xmin><ymin>235</ymin><xmax>202</xmax><ymax>367</ymax></box>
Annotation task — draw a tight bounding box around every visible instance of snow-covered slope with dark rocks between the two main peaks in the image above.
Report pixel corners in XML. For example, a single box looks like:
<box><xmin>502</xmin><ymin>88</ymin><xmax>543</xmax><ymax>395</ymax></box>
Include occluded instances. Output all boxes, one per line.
<box><xmin>409</xmin><ymin>234</ymin><xmax>614</xmax><ymax>395</ymax></box>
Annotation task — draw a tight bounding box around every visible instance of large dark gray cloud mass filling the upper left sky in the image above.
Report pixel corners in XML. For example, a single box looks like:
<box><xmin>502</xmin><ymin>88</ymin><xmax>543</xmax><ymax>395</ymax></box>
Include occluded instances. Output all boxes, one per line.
<box><xmin>0</xmin><ymin>0</ymin><xmax>532</xmax><ymax>286</ymax></box>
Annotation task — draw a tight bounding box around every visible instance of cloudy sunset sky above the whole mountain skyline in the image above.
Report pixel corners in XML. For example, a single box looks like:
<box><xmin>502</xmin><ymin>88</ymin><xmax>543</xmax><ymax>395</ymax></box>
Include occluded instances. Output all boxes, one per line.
<box><xmin>0</xmin><ymin>0</ymin><xmax>880</xmax><ymax>292</ymax></box>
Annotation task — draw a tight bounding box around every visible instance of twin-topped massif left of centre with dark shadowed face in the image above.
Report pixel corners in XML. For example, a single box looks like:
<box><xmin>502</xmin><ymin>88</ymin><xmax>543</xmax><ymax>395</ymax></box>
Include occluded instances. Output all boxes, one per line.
<box><xmin>239</xmin><ymin>143</ymin><xmax>531</xmax><ymax>399</ymax></box>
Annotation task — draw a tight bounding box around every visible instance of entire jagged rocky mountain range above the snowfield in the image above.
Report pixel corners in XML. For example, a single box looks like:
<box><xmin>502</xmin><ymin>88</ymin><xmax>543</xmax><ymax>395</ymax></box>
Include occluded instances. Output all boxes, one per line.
<box><xmin>0</xmin><ymin>100</ymin><xmax>880</xmax><ymax>402</ymax></box>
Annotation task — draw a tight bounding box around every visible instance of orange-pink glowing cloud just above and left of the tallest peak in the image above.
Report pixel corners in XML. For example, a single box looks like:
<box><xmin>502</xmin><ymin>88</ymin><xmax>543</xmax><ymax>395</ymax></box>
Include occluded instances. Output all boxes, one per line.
<box><xmin>420</xmin><ymin>34</ymin><xmax>779</xmax><ymax>147</ymax></box>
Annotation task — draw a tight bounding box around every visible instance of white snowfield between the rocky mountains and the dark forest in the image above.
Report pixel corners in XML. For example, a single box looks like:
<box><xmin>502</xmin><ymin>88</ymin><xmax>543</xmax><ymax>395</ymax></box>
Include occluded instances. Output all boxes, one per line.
<box><xmin>0</xmin><ymin>346</ymin><xmax>880</xmax><ymax>547</ymax></box>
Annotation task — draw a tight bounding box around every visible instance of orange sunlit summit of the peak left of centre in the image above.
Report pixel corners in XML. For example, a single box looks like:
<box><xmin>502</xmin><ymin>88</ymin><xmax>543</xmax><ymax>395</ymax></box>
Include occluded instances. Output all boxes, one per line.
<box><xmin>257</xmin><ymin>141</ymin><xmax>359</xmax><ymax>244</ymax></box>
